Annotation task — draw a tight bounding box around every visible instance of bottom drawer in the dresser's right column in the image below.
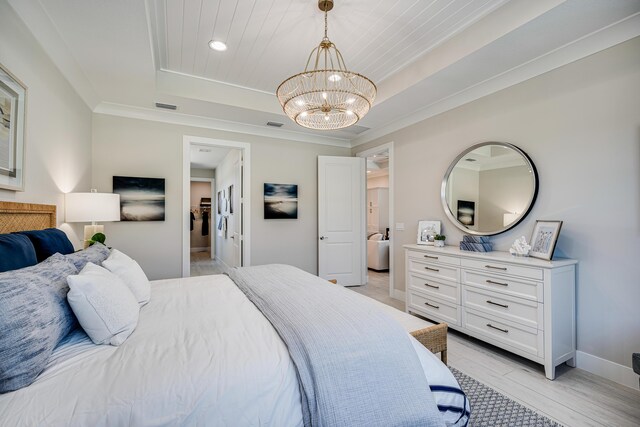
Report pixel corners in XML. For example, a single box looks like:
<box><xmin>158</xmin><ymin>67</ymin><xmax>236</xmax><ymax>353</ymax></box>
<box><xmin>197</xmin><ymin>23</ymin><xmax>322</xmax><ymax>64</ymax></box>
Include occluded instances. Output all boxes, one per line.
<box><xmin>462</xmin><ymin>308</ymin><xmax>544</xmax><ymax>357</ymax></box>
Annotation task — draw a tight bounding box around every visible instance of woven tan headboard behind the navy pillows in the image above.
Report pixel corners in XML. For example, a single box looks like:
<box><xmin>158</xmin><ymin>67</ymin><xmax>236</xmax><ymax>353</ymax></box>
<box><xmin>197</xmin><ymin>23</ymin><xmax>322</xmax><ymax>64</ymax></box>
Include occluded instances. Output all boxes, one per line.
<box><xmin>0</xmin><ymin>202</ymin><xmax>56</xmax><ymax>233</ymax></box>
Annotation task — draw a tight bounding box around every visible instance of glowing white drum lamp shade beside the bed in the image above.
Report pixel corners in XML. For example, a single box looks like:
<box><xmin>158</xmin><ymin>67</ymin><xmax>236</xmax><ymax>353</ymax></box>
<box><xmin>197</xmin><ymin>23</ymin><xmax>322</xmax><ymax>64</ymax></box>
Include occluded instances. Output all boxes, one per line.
<box><xmin>64</xmin><ymin>193</ymin><xmax>120</xmax><ymax>222</ymax></box>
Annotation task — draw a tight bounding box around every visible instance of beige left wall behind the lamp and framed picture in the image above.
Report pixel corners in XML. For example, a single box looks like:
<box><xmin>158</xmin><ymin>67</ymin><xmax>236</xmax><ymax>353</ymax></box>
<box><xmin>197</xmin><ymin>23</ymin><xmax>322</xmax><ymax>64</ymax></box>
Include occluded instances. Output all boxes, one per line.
<box><xmin>0</xmin><ymin>0</ymin><xmax>91</xmax><ymax>248</ymax></box>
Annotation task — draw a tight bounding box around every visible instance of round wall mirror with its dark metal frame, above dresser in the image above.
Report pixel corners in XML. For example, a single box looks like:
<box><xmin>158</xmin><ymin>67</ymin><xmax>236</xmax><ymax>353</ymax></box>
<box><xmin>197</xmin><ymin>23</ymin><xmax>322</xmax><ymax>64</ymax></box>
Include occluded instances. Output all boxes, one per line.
<box><xmin>441</xmin><ymin>142</ymin><xmax>538</xmax><ymax>236</ymax></box>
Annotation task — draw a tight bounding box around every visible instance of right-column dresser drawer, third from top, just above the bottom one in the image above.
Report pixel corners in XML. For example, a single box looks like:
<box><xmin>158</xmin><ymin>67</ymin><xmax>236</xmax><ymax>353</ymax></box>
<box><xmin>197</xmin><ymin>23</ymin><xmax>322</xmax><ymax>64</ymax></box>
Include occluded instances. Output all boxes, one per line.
<box><xmin>462</xmin><ymin>286</ymin><xmax>544</xmax><ymax>329</ymax></box>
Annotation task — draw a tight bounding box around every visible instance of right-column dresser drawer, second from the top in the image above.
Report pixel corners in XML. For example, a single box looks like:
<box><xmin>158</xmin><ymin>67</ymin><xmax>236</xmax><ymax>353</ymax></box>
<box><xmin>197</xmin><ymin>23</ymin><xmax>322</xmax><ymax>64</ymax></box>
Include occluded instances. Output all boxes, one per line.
<box><xmin>460</xmin><ymin>270</ymin><xmax>543</xmax><ymax>302</ymax></box>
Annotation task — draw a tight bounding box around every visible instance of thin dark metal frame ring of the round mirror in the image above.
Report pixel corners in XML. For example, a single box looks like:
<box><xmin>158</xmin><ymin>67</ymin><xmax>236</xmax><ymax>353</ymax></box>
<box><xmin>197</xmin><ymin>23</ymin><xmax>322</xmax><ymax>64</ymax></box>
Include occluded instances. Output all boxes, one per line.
<box><xmin>440</xmin><ymin>141</ymin><xmax>539</xmax><ymax>236</ymax></box>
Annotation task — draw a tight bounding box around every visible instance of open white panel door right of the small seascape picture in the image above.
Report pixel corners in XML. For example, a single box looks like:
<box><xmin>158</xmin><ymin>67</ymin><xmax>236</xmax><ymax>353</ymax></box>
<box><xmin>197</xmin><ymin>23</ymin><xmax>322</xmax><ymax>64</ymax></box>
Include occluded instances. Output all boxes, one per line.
<box><xmin>318</xmin><ymin>156</ymin><xmax>366</xmax><ymax>286</ymax></box>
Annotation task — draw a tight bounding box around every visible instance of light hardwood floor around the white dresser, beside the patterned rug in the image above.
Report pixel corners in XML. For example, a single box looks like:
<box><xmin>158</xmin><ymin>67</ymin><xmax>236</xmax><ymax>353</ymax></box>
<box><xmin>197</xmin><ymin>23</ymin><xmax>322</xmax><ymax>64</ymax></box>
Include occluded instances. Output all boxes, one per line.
<box><xmin>349</xmin><ymin>270</ymin><xmax>640</xmax><ymax>427</ymax></box>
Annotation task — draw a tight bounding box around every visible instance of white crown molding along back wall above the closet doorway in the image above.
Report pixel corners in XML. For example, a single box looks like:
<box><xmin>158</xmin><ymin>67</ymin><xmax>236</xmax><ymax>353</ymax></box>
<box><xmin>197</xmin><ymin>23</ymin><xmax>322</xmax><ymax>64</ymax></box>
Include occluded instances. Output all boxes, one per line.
<box><xmin>93</xmin><ymin>102</ymin><xmax>350</xmax><ymax>148</ymax></box>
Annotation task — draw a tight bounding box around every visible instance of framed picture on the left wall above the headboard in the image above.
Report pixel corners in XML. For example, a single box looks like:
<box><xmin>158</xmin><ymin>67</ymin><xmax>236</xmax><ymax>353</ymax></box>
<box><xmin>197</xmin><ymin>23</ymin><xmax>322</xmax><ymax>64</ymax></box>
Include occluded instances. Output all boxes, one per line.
<box><xmin>0</xmin><ymin>64</ymin><xmax>27</xmax><ymax>191</ymax></box>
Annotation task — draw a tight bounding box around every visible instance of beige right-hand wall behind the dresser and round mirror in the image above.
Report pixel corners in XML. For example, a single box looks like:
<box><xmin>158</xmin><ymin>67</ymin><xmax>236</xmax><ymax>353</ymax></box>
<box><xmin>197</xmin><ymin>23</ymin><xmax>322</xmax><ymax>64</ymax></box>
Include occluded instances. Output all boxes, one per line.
<box><xmin>354</xmin><ymin>38</ymin><xmax>640</xmax><ymax>378</ymax></box>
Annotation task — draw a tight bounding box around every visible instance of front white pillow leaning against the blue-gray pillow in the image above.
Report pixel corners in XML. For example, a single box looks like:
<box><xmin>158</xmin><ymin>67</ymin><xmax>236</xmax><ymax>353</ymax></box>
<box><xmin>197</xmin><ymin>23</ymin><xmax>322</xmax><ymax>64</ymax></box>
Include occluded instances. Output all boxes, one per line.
<box><xmin>67</xmin><ymin>262</ymin><xmax>140</xmax><ymax>345</ymax></box>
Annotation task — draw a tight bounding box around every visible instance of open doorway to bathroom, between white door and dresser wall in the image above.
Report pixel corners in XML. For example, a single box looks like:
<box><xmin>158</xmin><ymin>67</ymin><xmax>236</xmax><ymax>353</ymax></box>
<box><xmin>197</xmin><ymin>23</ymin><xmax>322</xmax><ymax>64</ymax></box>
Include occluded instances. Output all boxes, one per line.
<box><xmin>356</xmin><ymin>142</ymin><xmax>404</xmax><ymax>310</ymax></box>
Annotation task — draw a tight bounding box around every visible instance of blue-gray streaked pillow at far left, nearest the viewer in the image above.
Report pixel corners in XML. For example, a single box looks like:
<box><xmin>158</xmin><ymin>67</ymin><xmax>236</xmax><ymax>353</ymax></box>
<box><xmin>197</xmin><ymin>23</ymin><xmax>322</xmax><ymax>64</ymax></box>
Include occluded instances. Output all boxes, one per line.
<box><xmin>0</xmin><ymin>254</ymin><xmax>78</xmax><ymax>393</ymax></box>
